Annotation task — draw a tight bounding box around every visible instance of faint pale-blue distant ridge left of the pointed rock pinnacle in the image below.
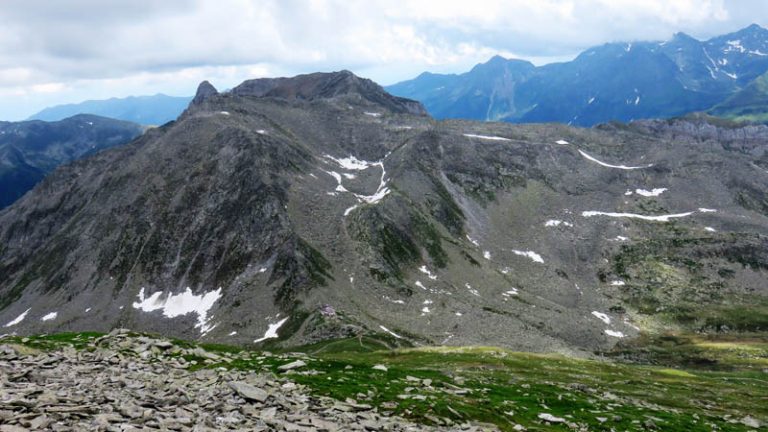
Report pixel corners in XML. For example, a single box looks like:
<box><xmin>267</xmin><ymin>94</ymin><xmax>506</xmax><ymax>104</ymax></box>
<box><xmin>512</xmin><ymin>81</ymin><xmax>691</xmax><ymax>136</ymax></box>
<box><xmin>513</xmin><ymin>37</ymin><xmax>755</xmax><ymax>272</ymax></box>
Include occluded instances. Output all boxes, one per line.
<box><xmin>29</xmin><ymin>94</ymin><xmax>192</xmax><ymax>125</ymax></box>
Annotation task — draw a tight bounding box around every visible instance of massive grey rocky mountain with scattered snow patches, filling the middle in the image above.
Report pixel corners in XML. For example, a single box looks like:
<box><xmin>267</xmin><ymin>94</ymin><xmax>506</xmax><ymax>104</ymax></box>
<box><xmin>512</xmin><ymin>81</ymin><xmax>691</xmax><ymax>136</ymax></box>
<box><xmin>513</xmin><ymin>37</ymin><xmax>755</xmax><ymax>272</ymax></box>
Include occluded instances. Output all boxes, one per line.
<box><xmin>0</xmin><ymin>72</ymin><xmax>768</xmax><ymax>351</ymax></box>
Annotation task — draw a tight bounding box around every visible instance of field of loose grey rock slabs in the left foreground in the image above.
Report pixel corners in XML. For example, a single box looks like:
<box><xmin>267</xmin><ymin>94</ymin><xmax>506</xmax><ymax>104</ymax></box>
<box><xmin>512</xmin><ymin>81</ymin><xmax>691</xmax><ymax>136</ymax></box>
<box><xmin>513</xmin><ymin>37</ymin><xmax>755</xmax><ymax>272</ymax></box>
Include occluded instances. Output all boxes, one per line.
<box><xmin>0</xmin><ymin>331</ymin><xmax>495</xmax><ymax>432</ymax></box>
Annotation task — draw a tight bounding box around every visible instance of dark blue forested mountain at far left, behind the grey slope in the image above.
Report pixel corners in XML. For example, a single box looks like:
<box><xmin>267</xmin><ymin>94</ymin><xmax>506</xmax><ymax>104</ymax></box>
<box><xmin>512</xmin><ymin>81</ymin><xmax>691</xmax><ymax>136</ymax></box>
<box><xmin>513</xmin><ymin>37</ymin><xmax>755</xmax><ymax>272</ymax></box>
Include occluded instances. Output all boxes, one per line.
<box><xmin>0</xmin><ymin>114</ymin><xmax>144</xmax><ymax>209</ymax></box>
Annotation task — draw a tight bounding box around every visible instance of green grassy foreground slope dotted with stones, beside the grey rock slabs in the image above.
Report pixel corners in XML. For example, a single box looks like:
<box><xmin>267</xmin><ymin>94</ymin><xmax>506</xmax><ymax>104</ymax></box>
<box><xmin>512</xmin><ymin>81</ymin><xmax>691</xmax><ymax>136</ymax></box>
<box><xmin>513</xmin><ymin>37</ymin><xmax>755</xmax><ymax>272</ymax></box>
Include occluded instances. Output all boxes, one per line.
<box><xmin>3</xmin><ymin>334</ymin><xmax>768</xmax><ymax>431</ymax></box>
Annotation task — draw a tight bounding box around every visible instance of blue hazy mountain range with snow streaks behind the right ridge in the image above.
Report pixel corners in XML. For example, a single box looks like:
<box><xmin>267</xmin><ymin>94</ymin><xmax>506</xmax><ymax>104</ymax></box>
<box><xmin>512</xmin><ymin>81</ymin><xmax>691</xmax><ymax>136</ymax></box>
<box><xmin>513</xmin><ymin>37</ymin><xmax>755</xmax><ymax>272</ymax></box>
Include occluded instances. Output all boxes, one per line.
<box><xmin>387</xmin><ymin>24</ymin><xmax>768</xmax><ymax>126</ymax></box>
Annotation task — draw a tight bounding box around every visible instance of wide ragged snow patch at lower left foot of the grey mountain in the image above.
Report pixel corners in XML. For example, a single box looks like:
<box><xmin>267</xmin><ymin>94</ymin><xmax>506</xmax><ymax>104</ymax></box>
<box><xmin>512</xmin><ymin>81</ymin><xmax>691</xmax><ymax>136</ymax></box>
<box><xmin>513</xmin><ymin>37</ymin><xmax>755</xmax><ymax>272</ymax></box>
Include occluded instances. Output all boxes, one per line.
<box><xmin>133</xmin><ymin>287</ymin><xmax>221</xmax><ymax>333</ymax></box>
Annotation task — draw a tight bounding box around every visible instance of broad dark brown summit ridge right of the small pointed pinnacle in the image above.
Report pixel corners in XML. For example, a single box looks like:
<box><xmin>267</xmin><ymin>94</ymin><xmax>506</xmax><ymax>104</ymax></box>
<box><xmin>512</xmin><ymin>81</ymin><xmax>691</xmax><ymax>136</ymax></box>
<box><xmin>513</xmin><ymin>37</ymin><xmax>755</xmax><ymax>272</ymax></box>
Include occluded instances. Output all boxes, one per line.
<box><xmin>232</xmin><ymin>70</ymin><xmax>426</xmax><ymax>115</ymax></box>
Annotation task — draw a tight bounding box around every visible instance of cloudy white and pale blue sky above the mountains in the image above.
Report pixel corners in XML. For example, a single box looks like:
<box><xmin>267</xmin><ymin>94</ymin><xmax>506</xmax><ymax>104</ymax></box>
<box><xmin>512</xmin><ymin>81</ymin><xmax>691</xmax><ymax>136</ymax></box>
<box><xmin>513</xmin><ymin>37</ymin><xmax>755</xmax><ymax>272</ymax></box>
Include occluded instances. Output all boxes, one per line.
<box><xmin>0</xmin><ymin>0</ymin><xmax>768</xmax><ymax>120</ymax></box>
